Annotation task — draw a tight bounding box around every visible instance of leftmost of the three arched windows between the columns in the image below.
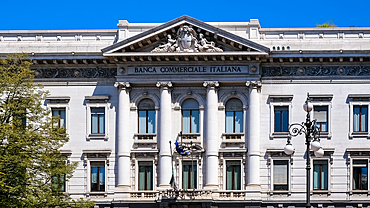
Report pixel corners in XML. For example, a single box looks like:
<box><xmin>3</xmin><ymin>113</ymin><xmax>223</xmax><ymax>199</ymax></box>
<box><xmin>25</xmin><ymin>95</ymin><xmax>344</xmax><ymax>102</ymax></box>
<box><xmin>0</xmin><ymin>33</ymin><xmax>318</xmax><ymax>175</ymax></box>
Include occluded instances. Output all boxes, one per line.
<box><xmin>138</xmin><ymin>99</ymin><xmax>155</xmax><ymax>134</ymax></box>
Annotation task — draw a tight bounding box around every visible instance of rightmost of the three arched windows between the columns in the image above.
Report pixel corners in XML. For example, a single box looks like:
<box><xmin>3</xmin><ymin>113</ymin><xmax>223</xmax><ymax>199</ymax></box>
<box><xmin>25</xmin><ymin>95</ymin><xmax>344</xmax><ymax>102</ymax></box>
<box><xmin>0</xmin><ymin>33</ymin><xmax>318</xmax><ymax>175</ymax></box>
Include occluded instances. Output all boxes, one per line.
<box><xmin>226</xmin><ymin>98</ymin><xmax>243</xmax><ymax>133</ymax></box>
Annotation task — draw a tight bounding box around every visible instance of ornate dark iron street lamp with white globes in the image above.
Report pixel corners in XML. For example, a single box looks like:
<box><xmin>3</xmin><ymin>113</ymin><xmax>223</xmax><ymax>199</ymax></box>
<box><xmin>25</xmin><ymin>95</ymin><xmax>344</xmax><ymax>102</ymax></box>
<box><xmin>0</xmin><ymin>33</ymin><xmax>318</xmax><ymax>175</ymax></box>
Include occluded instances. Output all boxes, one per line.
<box><xmin>284</xmin><ymin>93</ymin><xmax>324</xmax><ymax>207</ymax></box>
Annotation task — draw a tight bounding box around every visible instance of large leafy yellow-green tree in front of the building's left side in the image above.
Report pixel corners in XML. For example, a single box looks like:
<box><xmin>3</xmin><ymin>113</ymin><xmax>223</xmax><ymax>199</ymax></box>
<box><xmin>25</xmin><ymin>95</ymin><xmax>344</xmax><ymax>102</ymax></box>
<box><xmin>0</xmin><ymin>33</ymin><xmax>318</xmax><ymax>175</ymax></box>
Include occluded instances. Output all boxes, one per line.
<box><xmin>0</xmin><ymin>54</ymin><xmax>94</xmax><ymax>207</ymax></box>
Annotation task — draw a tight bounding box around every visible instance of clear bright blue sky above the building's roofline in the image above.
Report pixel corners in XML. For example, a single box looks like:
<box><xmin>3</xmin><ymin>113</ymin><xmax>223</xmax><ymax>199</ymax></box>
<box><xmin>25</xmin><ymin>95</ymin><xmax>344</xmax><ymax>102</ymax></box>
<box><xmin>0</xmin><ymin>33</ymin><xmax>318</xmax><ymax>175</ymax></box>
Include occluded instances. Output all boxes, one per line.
<box><xmin>0</xmin><ymin>0</ymin><xmax>370</xmax><ymax>30</ymax></box>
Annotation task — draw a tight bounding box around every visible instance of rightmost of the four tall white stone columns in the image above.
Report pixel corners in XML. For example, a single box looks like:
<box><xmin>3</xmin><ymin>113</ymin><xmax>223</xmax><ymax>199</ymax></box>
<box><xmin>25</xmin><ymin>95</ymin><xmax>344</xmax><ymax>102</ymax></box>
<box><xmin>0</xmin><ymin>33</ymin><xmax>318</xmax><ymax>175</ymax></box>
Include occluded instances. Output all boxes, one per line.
<box><xmin>246</xmin><ymin>81</ymin><xmax>261</xmax><ymax>198</ymax></box>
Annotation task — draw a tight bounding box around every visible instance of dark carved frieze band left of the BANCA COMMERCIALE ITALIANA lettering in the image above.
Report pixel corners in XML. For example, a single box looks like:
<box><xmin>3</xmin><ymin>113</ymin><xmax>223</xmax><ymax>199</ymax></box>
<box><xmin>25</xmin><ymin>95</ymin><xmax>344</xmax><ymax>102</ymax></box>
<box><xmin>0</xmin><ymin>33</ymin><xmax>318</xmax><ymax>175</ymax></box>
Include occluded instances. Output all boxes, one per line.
<box><xmin>33</xmin><ymin>67</ymin><xmax>117</xmax><ymax>78</ymax></box>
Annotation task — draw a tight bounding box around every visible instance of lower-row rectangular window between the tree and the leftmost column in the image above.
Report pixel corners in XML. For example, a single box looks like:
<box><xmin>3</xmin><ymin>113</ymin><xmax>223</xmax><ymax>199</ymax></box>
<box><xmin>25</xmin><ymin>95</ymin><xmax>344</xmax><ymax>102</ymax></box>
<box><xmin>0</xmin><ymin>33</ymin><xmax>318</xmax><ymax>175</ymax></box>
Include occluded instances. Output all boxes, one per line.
<box><xmin>90</xmin><ymin>162</ymin><xmax>105</xmax><ymax>191</ymax></box>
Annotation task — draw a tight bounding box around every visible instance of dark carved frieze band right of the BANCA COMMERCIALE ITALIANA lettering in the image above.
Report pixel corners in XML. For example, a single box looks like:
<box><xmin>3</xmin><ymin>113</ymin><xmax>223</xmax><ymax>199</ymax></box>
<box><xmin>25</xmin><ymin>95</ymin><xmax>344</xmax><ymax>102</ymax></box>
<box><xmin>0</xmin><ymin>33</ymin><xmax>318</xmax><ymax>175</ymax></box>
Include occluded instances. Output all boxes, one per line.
<box><xmin>262</xmin><ymin>66</ymin><xmax>370</xmax><ymax>77</ymax></box>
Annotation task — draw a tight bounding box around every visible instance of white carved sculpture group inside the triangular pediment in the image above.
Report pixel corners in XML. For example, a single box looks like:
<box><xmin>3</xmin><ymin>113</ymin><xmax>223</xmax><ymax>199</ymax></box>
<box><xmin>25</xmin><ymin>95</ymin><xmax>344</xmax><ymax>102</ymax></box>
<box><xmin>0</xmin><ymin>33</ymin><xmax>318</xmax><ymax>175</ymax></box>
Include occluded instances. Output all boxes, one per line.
<box><xmin>152</xmin><ymin>25</ymin><xmax>223</xmax><ymax>53</ymax></box>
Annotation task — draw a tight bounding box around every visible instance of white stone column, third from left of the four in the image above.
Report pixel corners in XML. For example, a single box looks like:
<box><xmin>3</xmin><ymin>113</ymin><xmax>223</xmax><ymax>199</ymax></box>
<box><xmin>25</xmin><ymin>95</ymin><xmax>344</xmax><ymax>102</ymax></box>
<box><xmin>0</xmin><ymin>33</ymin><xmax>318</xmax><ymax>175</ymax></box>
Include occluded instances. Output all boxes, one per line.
<box><xmin>203</xmin><ymin>81</ymin><xmax>220</xmax><ymax>189</ymax></box>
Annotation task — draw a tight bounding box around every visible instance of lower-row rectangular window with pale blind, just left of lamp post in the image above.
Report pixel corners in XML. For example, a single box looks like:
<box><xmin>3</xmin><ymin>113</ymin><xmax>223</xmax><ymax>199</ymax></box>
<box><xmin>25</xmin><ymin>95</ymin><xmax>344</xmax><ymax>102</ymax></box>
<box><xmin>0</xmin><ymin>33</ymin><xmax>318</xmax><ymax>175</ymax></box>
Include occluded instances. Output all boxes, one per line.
<box><xmin>273</xmin><ymin>160</ymin><xmax>289</xmax><ymax>191</ymax></box>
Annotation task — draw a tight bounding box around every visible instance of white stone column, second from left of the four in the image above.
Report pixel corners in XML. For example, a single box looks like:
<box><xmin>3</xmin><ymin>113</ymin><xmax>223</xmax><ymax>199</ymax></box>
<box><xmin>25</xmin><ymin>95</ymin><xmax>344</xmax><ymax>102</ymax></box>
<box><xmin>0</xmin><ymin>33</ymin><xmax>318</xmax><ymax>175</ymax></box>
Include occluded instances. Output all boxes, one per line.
<box><xmin>156</xmin><ymin>82</ymin><xmax>172</xmax><ymax>189</ymax></box>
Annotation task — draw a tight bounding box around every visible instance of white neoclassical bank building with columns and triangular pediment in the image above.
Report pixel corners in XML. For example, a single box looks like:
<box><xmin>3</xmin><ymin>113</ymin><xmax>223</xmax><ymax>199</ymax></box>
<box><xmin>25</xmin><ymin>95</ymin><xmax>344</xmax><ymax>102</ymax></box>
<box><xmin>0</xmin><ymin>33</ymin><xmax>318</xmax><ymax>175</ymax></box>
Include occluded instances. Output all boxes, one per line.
<box><xmin>0</xmin><ymin>16</ymin><xmax>370</xmax><ymax>208</ymax></box>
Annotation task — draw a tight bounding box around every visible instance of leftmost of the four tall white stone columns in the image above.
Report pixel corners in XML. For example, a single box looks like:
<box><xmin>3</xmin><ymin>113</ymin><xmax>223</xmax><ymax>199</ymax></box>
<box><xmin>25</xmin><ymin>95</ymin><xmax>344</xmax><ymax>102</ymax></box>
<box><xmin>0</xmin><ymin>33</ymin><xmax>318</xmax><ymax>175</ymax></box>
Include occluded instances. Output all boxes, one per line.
<box><xmin>114</xmin><ymin>82</ymin><xmax>131</xmax><ymax>191</ymax></box>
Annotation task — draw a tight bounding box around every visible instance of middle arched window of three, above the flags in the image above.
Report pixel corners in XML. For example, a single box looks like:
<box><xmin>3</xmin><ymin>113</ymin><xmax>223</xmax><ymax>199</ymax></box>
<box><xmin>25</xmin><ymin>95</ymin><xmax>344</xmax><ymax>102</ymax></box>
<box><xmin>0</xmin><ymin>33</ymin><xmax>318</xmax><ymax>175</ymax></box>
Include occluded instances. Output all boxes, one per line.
<box><xmin>182</xmin><ymin>99</ymin><xmax>199</xmax><ymax>133</ymax></box>
